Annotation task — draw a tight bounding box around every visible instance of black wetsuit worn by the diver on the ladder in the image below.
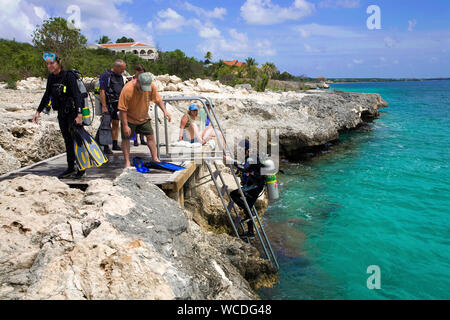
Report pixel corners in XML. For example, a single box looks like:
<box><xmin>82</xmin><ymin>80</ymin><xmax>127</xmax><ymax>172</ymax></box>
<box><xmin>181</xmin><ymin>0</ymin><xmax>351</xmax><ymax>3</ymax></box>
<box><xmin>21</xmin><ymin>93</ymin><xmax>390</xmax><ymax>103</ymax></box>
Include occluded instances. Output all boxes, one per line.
<box><xmin>230</xmin><ymin>157</ymin><xmax>265</xmax><ymax>233</ymax></box>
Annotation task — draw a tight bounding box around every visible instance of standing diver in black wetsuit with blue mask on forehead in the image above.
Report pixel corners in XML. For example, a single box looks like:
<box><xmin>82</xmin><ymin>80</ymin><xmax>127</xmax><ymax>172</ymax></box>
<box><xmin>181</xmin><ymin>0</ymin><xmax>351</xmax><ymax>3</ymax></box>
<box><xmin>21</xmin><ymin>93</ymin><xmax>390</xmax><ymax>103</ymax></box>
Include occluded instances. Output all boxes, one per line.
<box><xmin>33</xmin><ymin>52</ymin><xmax>84</xmax><ymax>178</ymax></box>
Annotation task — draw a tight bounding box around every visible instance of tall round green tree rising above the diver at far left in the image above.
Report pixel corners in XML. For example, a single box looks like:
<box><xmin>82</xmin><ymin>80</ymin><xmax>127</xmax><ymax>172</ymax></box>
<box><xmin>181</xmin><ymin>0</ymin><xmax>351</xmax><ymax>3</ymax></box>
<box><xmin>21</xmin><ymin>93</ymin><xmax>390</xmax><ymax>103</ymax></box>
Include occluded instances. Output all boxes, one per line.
<box><xmin>32</xmin><ymin>17</ymin><xmax>87</xmax><ymax>65</ymax></box>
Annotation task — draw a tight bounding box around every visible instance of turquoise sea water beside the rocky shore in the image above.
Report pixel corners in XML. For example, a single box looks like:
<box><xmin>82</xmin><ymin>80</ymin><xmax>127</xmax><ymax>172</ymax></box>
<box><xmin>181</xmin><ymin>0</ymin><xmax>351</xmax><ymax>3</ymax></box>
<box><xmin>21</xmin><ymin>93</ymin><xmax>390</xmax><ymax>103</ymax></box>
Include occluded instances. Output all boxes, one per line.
<box><xmin>259</xmin><ymin>81</ymin><xmax>450</xmax><ymax>299</ymax></box>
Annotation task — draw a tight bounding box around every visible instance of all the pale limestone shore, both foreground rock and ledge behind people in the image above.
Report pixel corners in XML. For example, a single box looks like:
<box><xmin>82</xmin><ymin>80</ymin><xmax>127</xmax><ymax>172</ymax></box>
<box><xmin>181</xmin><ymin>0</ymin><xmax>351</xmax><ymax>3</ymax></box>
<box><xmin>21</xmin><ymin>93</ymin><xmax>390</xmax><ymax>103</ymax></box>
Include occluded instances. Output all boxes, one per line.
<box><xmin>0</xmin><ymin>75</ymin><xmax>387</xmax><ymax>299</ymax></box>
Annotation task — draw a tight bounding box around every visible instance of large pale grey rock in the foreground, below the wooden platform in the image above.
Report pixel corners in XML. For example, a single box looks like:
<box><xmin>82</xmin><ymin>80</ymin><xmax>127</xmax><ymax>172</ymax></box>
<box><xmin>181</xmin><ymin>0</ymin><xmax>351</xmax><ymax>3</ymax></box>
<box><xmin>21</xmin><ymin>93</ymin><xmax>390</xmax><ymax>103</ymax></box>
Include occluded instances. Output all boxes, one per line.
<box><xmin>0</xmin><ymin>170</ymin><xmax>277</xmax><ymax>299</ymax></box>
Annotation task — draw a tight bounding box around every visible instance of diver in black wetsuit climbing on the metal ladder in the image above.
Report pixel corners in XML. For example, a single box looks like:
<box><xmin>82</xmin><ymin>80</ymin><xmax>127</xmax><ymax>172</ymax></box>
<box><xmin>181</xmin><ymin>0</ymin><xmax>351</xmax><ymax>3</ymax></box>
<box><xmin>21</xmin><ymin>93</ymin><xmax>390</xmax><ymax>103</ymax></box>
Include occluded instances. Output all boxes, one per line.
<box><xmin>224</xmin><ymin>139</ymin><xmax>266</xmax><ymax>238</ymax></box>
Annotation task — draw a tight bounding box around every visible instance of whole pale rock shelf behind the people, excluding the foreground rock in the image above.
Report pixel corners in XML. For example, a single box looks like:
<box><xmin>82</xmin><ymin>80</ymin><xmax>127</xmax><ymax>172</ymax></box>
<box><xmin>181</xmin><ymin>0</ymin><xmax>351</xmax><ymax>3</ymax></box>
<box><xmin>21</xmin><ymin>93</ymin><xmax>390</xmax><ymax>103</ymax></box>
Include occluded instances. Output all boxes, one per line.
<box><xmin>0</xmin><ymin>75</ymin><xmax>387</xmax><ymax>170</ymax></box>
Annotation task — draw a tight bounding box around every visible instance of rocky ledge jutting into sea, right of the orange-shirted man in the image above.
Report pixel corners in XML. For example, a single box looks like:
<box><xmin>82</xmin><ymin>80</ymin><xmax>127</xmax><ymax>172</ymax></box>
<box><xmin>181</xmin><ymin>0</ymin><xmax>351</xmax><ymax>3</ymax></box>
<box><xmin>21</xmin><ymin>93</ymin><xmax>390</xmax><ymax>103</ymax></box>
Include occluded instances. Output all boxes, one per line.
<box><xmin>160</xmin><ymin>83</ymin><xmax>388</xmax><ymax>160</ymax></box>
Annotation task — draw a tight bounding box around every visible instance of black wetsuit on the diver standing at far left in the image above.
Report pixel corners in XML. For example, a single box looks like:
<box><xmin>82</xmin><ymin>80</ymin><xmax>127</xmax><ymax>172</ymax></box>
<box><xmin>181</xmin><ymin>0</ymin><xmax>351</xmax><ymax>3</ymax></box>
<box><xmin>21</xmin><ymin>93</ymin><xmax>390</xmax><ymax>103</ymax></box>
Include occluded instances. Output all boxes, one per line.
<box><xmin>37</xmin><ymin>71</ymin><xmax>83</xmax><ymax>169</ymax></box>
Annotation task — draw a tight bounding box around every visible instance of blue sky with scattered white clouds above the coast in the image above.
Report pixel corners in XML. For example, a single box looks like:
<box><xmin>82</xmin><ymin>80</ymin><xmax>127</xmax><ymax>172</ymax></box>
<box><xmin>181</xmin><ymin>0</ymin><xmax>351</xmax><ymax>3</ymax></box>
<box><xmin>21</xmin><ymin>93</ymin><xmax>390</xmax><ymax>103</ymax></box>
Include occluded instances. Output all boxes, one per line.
<box><xmin>0</xmin><ymin>0</ymin><xmax>450</xmax><ymax>77</ymax></box>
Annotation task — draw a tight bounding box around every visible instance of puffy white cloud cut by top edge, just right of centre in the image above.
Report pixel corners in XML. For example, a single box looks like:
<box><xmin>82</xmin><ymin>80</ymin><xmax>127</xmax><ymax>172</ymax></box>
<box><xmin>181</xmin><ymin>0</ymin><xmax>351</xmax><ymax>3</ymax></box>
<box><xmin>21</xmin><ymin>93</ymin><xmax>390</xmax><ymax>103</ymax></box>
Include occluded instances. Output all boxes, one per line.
<box><xmin>241</xmin><ymin>0</ymin><xmax>315</xmax><ymax>25</ymax></box>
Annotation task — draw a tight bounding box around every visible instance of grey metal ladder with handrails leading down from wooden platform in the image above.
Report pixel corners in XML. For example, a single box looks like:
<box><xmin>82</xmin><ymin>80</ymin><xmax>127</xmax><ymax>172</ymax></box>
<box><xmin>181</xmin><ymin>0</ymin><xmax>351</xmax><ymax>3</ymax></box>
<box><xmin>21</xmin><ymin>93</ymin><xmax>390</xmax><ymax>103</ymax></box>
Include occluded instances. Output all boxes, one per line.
<box><xmin>155</xmin><ymin>96</ymin><xmax>279</xmax><ymax>269</ymax></box>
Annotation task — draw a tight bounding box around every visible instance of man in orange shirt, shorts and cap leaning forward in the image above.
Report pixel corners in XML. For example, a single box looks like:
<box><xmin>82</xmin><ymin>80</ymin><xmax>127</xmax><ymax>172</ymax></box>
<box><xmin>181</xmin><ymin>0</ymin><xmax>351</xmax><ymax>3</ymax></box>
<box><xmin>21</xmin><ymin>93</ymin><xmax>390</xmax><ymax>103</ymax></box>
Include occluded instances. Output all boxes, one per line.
<box><xmin>118</xmin><ymin>72</ymin><xmax>171</xmax><ymax>168</ymax></box>
